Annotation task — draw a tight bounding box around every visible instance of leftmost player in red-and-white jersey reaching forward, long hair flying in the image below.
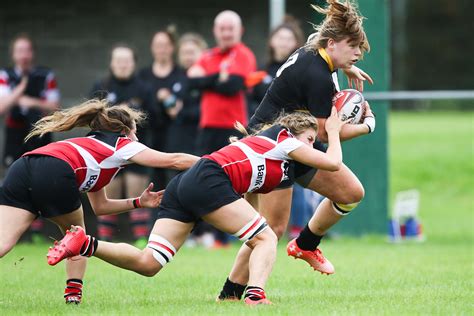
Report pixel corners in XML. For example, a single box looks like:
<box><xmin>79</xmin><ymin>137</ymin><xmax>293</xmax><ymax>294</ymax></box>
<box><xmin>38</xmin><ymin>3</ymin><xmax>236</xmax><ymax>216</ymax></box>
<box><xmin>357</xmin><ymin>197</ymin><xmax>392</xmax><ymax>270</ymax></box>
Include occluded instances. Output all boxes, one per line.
<box><xmin>0</xmin><ymin>100</ymin><xmax>199</xmax><ymax>304</ymax></box>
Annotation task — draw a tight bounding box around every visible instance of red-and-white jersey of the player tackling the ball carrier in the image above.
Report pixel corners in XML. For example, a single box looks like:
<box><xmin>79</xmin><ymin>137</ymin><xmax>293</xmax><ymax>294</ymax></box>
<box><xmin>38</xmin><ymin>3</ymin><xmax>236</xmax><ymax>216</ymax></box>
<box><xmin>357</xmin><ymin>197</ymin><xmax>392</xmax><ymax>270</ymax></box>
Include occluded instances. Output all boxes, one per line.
<box><xmin>204</xmin><ymin>125</ymin><xmax>304</xmax><ymax>194</ymax></box>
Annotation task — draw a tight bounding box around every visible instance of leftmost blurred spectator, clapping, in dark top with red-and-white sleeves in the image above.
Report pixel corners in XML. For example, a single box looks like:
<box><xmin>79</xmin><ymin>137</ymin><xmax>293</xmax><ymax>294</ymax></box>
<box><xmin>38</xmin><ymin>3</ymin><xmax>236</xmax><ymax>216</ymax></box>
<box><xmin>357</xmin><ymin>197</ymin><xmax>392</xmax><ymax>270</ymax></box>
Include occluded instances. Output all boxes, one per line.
<box><xmin>0</xmin><ymin>34</ymin><xmax>59</xmax><ymax>242</ymax></box>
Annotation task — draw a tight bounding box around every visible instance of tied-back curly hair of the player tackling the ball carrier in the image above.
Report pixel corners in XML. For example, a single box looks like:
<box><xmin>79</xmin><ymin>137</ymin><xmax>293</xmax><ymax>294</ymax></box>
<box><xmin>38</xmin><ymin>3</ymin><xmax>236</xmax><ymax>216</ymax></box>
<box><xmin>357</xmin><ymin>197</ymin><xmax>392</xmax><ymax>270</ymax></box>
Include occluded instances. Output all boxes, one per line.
<box><xmin>229</xmin><ymin>111</ymin><xmax>318</xmax><ymax>143</ymax></box>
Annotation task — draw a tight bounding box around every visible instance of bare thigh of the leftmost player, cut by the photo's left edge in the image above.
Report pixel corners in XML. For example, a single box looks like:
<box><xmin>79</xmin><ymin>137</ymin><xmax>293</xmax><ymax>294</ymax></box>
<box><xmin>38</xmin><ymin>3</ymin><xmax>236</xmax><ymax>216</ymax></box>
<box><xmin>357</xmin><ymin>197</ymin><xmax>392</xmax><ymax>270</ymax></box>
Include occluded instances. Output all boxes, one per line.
<box><xmin>0</xmin><ymin>205</ymin><xmax>36</xmax><ymax>258</ymax></box>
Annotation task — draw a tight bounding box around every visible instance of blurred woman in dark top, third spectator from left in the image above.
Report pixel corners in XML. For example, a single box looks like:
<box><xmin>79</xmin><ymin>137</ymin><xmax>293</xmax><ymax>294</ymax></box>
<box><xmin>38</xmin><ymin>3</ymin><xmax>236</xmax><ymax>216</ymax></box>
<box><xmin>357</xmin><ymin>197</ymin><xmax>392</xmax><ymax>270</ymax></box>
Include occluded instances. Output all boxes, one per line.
<box><xmin>139</xmin><ymin>26</ymin><xmax>185</xmax><ymax>190</ymax></box>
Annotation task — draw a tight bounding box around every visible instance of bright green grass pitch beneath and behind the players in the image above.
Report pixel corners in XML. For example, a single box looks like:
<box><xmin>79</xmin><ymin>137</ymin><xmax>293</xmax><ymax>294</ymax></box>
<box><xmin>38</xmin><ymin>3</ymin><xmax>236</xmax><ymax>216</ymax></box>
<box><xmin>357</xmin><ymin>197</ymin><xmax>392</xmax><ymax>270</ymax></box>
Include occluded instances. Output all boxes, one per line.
<box><xmin>0</xmin><ymin>112</ymin><xmax>474</xmax><ymax>315</ymax></box>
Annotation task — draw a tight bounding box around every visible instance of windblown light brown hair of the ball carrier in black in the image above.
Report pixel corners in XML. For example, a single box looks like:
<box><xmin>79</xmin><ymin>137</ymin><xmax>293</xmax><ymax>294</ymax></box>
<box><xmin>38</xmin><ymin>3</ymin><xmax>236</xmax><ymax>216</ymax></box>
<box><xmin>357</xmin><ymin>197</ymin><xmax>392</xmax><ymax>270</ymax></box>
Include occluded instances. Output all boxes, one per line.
<box><xmin>308</xmin><ymin>0</ymin><xmax>370</xmax><ymax>54</ymax></box>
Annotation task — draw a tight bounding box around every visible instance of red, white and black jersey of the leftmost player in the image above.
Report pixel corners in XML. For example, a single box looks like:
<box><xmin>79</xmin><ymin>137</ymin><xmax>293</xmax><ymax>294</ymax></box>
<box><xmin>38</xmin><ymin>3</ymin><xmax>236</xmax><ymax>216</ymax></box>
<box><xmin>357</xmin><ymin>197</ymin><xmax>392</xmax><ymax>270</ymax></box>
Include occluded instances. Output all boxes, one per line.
<box><xmin>24</xmin><ymin>131</ymin><xmax>148</xmax><ymax>192</ymax></box>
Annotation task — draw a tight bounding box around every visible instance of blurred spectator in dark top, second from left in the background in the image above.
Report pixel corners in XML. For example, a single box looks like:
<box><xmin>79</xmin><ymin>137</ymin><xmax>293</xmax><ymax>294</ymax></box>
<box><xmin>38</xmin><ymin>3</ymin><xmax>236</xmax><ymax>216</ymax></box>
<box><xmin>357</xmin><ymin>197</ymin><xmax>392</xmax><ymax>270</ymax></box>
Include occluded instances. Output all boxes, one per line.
<box><xmin>90</xmin><ymin>44</ymin><xmax>155</xmax><ymax>247</ymax></box>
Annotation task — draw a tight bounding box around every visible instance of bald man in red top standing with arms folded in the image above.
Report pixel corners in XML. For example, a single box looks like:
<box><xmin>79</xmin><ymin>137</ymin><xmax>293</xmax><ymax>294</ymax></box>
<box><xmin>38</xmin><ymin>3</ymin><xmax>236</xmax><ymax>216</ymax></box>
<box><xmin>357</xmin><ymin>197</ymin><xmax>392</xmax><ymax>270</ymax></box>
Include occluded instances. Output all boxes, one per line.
<box><xmin>188</xmin><ymin>10</ymin><xmax>256</xmax><ymax>247</ymax></box>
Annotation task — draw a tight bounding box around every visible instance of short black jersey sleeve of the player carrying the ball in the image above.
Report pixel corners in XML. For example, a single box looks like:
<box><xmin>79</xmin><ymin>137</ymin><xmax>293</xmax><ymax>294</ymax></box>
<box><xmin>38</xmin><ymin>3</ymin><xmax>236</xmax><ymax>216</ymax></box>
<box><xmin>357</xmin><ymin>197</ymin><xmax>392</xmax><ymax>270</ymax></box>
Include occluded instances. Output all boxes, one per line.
<box><xmin>302</xmin><ymin>64</ymin><xmax>334</xmax><ymax>118</ymax></box>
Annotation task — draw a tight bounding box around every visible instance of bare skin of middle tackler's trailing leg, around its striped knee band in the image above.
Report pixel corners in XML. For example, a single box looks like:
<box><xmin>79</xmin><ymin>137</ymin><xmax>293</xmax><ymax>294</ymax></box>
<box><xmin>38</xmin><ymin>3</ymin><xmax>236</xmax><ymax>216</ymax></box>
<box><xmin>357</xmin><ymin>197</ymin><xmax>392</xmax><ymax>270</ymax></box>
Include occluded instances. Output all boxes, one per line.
<box><xmin>94</xmin><ymin>218</ymin><xmax>194</xmax><ymax>276</ymax></box>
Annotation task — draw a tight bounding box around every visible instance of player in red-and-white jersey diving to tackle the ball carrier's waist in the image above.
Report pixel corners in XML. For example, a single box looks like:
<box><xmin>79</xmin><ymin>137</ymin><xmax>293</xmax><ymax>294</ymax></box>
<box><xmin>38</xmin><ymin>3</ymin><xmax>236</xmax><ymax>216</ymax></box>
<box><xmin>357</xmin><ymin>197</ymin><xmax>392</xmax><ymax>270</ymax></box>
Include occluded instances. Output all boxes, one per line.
<box><xmin>48</xmin><ymin>109</ymin><xmax>344</xmax><ymax>305</ymax></box>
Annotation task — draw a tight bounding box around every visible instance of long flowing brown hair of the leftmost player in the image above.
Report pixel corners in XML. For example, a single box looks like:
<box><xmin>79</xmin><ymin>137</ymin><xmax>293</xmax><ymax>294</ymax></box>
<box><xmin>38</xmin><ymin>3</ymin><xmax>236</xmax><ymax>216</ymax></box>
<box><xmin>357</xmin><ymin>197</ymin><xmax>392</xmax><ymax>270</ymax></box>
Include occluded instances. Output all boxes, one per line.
<box><xmin>25</xmin><ymin>99</ymin><xmax>145</xmax><ymax>141</ymax></box>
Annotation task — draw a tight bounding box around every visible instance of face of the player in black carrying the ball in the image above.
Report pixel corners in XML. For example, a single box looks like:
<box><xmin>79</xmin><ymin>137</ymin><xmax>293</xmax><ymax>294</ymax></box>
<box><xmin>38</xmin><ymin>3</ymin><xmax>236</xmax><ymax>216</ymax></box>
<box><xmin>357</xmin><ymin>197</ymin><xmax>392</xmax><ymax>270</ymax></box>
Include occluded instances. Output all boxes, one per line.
<box><xmin>326</xmin><ymin>38</ymin><xmax>362</xmax><ymax>69</ymax></box>
